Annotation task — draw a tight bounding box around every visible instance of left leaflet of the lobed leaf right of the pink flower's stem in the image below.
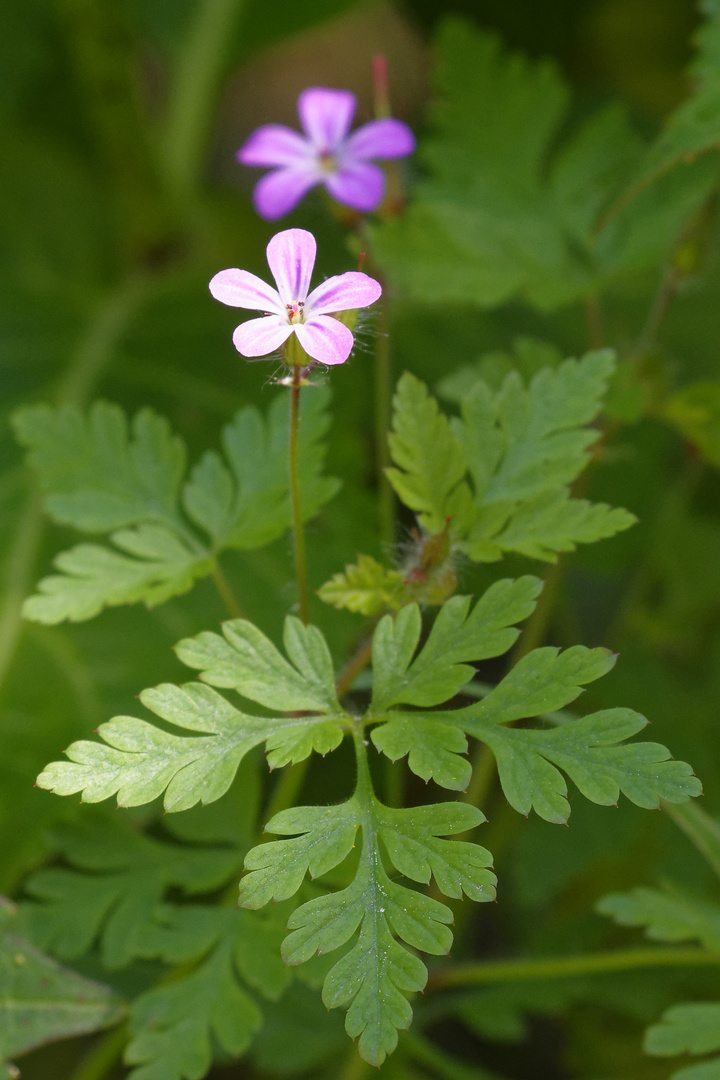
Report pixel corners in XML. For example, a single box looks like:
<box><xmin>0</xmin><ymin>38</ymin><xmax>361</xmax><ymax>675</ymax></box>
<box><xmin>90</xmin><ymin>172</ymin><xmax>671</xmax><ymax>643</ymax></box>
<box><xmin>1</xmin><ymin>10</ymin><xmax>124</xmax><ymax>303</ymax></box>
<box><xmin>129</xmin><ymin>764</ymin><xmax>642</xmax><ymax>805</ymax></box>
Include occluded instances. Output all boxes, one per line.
<box><xmin>386</xmin><ymin>372</ymin><xmax>470</xmax><ymax>532</ymax></box>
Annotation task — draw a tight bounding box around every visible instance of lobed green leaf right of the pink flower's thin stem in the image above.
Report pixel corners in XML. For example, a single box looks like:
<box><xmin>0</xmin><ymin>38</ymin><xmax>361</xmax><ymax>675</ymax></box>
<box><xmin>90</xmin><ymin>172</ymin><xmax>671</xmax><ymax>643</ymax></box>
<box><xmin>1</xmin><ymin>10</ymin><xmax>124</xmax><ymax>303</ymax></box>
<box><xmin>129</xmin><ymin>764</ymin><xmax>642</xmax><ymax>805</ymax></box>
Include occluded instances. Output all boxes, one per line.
<box><xmin>388</xmin><ymin>360</ymin><xmax>635</xmax><ymax>562</ymax></box>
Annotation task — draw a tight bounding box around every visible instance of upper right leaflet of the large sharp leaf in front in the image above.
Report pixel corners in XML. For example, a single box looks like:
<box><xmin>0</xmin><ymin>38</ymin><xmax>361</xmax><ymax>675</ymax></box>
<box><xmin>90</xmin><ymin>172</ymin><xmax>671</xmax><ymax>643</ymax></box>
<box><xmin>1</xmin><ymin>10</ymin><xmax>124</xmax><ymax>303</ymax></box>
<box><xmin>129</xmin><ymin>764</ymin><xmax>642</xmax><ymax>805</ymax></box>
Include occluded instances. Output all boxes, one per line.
<box><xmin>372</xmin><ymin>577</ymin><xmax>542</xmax><ymax>713</ymax></box>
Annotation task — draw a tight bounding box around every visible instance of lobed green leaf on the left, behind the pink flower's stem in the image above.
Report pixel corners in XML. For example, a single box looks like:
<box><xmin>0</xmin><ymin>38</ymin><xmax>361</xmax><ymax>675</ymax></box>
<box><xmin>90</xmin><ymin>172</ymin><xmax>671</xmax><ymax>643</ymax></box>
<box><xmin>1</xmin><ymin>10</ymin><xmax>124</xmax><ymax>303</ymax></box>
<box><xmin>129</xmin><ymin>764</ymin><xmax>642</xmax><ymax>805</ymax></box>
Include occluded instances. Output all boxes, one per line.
<box><xmin>14</xmin><ymin>389</ymin><xmax>338</xmax><ymax>623</ymax></box>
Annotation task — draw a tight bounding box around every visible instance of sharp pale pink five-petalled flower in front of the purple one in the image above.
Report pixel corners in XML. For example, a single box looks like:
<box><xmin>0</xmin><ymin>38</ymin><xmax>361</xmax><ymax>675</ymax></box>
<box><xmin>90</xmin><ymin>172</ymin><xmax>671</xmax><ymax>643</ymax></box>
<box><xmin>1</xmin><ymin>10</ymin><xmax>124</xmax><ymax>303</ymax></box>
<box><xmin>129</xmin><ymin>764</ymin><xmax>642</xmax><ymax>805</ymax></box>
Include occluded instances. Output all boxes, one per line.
<box><xmin>209</xmin><ymin>229</ymin><xmax>382</xmax><ymax>364</ymax></box>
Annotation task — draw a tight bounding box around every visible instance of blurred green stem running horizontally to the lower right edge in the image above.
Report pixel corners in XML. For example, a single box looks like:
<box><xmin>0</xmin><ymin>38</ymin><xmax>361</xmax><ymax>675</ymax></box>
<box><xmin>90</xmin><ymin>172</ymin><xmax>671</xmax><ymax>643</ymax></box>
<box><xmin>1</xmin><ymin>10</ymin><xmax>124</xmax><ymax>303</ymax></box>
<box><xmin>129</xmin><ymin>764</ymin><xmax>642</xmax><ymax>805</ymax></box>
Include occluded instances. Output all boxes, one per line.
<box><xmin>427</xmin><ymin>948</ymin><xmax>720</xmax><ymax>990</ymax></box>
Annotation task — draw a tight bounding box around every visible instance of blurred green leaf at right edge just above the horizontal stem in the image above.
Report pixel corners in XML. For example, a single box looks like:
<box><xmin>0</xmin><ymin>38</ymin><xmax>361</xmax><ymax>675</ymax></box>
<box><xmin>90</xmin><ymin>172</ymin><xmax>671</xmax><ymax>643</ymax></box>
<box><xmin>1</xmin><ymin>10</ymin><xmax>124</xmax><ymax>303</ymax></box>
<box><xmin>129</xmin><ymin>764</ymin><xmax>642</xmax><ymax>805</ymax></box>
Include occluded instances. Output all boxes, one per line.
<box><xmin>596</xmin><ymin>886</ymin><xmax>720</xmax><ymax>949</ymax></box>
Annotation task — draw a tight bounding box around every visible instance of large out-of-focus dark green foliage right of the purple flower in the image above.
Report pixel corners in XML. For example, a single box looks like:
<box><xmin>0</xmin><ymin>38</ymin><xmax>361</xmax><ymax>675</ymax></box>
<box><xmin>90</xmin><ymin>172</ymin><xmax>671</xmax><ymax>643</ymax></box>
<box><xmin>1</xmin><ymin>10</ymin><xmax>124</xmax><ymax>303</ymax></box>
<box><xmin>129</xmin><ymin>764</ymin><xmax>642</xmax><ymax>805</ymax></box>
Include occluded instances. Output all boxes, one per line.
<box><xmin>375</xmin><ymin>19</ymin><xmax>719</xmax><ymax>310</ymax></box>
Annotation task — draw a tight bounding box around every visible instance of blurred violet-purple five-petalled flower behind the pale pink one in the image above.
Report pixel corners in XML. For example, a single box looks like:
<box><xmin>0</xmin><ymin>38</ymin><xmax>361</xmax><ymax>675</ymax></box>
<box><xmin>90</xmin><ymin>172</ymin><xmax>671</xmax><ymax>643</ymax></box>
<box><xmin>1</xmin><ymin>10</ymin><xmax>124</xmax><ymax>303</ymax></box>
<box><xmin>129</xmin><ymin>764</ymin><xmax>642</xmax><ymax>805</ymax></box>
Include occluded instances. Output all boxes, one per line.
<box><xmin>236</xmin><ymin>86</ymin><xmax>415</xmax><ymax>221</ymax></box>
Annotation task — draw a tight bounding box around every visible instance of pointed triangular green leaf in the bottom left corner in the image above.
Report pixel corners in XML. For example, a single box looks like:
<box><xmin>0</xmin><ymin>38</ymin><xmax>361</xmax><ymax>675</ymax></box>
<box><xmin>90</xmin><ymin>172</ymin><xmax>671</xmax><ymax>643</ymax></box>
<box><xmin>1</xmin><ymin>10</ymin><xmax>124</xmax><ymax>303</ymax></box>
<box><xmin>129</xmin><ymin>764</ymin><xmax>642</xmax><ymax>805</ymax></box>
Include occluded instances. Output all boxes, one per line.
<box><xmin>0</xmin><ymin>901</ymin><xmax>125</xmax><ymax>1063</ymax></box>
